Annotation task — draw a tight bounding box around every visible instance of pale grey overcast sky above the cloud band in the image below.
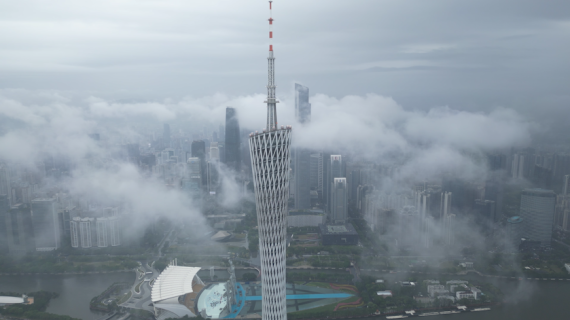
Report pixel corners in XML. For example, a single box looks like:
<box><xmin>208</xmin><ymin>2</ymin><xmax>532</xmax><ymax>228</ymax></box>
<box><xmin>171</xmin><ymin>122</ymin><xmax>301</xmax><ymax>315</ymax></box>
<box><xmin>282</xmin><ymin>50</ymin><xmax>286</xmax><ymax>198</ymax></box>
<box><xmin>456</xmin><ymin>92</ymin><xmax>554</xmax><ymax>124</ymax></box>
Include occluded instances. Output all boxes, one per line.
<box><xmin>0</xmin><ymin>0</ymin><xmax>570</xmax><ymax>142</ymax></box>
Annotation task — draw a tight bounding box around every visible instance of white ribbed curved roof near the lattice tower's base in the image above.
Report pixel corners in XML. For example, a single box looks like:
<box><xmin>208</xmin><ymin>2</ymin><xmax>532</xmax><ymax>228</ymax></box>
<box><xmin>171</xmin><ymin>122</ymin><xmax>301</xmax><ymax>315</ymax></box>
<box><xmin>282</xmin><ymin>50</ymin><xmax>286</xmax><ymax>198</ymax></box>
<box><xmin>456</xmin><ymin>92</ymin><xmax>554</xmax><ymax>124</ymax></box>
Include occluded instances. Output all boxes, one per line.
<box><xmin>151</xmin><ymin>266</ymin><xmax>202</xmax><ymax>303</ymax></box>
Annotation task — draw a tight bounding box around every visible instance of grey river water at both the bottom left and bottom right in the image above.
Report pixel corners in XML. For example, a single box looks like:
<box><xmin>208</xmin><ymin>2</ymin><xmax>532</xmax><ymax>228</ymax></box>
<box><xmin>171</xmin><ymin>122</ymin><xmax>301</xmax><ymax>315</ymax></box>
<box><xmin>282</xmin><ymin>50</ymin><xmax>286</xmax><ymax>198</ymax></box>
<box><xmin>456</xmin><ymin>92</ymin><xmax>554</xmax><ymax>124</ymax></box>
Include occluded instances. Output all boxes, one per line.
<box><xmin>0</xmin><ymin>272</ymin><xmax>570</xmax><ymax>320</ymax></box>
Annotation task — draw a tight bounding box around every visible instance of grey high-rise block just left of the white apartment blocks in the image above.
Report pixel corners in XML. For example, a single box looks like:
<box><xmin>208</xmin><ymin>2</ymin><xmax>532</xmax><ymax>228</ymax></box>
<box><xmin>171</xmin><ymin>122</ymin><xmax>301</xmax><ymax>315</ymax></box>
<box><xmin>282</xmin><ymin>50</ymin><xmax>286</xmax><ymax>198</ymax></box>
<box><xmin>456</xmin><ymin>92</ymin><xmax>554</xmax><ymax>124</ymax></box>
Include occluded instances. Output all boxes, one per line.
<box><xmin>32</xmin><ymin>198</ymin><xmax>61</xmax><ymax>251</ymax></box>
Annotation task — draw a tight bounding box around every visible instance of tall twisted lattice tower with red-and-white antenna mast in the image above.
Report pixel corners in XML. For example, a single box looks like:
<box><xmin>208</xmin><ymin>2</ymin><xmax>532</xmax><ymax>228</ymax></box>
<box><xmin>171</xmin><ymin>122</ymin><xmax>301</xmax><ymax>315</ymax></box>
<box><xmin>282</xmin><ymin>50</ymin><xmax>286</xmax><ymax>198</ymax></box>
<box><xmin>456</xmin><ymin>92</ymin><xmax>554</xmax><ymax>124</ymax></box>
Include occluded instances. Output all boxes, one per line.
<box><xmin>249</xmin><ymin>1</ymin><xmax>291</xmax><ymax>320</ymax></box>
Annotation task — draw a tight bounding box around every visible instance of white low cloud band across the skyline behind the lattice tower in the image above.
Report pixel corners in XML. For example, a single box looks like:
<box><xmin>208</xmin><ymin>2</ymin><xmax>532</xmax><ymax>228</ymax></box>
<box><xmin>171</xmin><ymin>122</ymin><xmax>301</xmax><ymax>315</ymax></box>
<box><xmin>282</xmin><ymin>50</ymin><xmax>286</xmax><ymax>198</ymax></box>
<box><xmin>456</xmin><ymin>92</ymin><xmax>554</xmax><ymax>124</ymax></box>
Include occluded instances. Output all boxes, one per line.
<box><xmin>0</xmin><ymin>92</ymin><xmax>532</xmax><ymax>180</ymax></box>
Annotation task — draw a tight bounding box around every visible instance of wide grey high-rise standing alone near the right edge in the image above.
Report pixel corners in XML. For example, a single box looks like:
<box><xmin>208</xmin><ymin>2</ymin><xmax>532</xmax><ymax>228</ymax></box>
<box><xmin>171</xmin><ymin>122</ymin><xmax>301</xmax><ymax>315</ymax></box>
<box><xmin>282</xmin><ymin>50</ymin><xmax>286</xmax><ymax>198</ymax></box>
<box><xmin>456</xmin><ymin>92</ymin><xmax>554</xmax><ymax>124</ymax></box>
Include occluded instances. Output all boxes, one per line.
<box><xmin>520</xmin><ymin>189</ymin><xmax>556</xmax><ymax>246</ymax></box>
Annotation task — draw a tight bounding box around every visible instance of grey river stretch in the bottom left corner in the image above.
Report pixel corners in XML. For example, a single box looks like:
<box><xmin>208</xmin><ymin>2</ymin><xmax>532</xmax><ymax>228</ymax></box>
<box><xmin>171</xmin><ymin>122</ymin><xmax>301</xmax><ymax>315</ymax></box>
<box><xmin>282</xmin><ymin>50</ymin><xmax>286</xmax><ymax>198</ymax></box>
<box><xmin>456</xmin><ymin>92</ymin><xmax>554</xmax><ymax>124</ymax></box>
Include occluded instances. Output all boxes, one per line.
<box><xmin>0</xmin><ymin>272</ymin><xmax>134</xmax><ymax>320</ymax></box>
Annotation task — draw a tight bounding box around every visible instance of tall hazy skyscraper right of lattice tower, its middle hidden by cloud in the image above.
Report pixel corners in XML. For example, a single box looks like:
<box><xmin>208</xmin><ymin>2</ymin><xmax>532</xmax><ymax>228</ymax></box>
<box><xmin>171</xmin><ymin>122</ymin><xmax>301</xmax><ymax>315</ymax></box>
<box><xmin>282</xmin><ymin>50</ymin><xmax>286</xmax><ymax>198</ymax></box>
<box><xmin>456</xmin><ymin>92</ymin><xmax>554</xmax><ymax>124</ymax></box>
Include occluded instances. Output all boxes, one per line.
<box><xmin>293</xmin><ymin>83</ymin><xmax>311</xmax><ymax>210</ymax></box>
